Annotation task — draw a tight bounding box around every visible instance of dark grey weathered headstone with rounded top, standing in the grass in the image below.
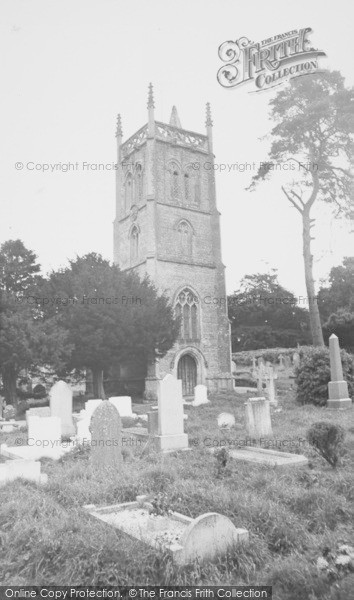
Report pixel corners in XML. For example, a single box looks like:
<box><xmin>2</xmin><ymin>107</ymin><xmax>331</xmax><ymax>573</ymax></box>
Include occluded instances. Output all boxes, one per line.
<box><xmin>90</xmin><ymin>400</ymin><xmax>123</xmax><ymax>475</ymax></box>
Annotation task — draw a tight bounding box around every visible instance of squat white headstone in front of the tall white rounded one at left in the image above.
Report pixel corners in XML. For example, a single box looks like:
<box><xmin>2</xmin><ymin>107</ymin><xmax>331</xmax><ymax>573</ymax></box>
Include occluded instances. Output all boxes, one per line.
<box><xmin>27</xmin><ymin>417</ymin><xmax>61</xmax><ymax>456</ymax></box>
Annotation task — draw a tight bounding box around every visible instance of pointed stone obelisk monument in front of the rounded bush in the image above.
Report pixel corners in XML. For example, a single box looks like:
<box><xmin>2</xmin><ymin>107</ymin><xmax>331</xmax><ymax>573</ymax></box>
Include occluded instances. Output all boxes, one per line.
<box><xmin>327</xmin><ymin>333</ymin><xmax>352</xmax><ymax>408</ymax></box>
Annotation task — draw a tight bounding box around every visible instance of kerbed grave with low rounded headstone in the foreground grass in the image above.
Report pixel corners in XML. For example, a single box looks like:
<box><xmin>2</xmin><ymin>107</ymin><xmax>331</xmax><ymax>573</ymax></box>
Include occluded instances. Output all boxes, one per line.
<box><xmin>83</xmin><ymin>494</ymin><xmax>248</xmax><ymax>565</ymax></box>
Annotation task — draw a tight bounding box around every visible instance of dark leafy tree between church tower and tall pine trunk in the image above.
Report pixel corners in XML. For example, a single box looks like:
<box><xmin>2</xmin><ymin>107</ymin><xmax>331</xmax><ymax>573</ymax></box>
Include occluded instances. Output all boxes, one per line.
<box><xmin>228</xmin><ymin>270</ymin><xmax>310</xmax><ymax>352</ymax></box>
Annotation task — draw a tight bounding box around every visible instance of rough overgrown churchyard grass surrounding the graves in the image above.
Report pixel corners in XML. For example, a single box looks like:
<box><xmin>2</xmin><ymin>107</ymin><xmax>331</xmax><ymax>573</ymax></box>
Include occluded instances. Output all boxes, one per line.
<box><xmin>0</xmin><ymin>385</ymin><xmax>354</xmax><ymax>600</ymax></box>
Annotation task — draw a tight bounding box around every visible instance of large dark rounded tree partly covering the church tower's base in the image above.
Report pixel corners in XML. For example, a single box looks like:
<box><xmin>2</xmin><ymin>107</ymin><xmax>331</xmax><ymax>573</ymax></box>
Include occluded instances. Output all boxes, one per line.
<box><xmin>44</xmin><ymin>253</ymin><xmax>179</xmax><ymax>398</ymax></box>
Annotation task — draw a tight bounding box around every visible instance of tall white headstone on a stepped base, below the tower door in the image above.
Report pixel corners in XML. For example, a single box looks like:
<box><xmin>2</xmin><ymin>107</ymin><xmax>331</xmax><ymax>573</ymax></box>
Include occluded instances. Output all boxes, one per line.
<box><xmin>156</xmin><ymin>374</ymin><xmax>188</xmax><ymax>451</ymax></box>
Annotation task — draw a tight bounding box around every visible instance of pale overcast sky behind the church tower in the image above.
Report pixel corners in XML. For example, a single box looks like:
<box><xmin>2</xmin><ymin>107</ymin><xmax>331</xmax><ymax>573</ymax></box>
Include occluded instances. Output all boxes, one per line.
<box><xmin>0</xmin><ymin>0</ymin><xmax>354</xmax><ymax>296</ymax></box>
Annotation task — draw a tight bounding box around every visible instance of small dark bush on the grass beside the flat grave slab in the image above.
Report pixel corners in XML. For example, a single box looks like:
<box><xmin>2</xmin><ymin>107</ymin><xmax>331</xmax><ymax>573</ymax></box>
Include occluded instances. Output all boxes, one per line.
<box><xmin>307</xmin><ymin>421</ymin><xmax>345</xmax><ymax>467</ymax></box>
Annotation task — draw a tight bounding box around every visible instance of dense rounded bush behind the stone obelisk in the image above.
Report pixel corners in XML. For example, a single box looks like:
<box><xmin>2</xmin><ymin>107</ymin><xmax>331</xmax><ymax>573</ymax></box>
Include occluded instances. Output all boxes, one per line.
<box><xmin>295</xmin><ymin>346</ymin><xmax>354</xmax><ymax>406</ymax></box>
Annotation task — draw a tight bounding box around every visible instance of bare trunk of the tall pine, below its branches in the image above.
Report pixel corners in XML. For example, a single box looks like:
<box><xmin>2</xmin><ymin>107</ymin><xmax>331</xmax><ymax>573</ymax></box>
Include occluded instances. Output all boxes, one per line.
<box><xmin>302</xmin><ymin>206</ymin><xmax>325</xmax><ymax>346</ymax></box>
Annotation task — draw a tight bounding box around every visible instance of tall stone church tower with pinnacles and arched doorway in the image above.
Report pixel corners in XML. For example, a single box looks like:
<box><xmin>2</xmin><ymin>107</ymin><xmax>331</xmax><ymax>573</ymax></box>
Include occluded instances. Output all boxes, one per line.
<box><xmin>114</xmin><ymin>84</ymin><xmax>232</xmax><ymax>396</ymax></box>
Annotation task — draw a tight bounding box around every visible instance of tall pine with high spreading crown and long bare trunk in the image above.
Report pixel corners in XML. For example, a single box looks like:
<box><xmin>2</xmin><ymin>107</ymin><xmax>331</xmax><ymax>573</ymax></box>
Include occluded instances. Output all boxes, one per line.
<box><xmin>249</xmin><ymin>71</ymin><xmax>354</xmax><ymax>345</ymax></box>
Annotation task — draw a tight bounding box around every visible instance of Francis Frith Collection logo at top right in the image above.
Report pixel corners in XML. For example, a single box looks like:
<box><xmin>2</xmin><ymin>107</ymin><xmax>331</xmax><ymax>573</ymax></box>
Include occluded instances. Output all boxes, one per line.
<box><xmin>217</xmin><ymin>27</ymin><xmax>326</xmax><ymax>92</ymax></box>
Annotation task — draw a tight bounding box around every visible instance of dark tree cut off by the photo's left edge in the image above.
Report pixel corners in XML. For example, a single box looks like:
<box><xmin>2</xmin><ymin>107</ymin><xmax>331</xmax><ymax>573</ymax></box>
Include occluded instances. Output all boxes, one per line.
<box><xmin>0</xmin><ymin>240</ymin><xmax>70</xmax><ymax>406</ymax></box>
